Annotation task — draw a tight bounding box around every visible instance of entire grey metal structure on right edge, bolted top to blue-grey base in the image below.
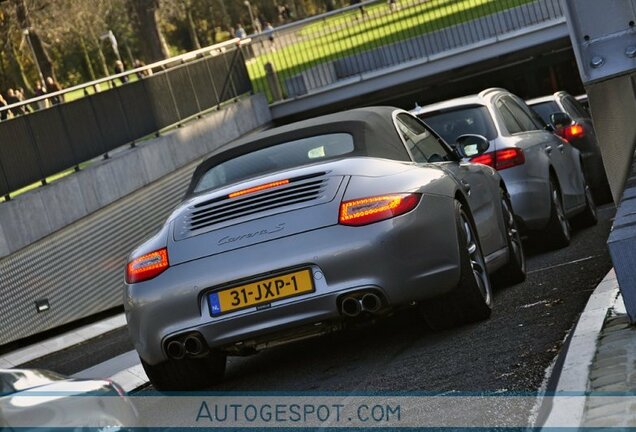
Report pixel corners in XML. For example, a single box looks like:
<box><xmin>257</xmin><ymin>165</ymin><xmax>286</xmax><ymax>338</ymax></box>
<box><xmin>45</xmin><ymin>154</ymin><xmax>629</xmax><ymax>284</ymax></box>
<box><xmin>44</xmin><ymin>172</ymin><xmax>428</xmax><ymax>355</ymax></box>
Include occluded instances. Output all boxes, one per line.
<box><xmin>565</xmin><ymin>0</ymin><xmax>636</xmax><ymax>324</ymax></box>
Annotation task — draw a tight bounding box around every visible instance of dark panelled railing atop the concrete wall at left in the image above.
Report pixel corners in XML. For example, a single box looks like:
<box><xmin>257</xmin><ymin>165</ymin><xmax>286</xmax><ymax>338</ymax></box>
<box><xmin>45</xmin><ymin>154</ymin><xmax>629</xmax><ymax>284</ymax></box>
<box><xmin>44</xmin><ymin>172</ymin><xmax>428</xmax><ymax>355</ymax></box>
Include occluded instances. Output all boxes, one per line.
<box><xmin>0</xmin><ymin>39</ymin><xmax>252</xmax><ymax>199</ymax></box>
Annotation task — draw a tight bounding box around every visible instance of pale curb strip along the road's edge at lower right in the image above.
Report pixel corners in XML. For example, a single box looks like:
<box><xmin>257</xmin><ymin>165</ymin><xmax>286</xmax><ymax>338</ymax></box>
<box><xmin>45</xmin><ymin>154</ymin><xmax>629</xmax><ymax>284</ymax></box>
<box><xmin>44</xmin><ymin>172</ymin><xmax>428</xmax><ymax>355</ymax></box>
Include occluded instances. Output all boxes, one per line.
<box><xmin>541</xmin><ymin>269</ymin><xmax>619</xmax><ymax>427</ymax></box>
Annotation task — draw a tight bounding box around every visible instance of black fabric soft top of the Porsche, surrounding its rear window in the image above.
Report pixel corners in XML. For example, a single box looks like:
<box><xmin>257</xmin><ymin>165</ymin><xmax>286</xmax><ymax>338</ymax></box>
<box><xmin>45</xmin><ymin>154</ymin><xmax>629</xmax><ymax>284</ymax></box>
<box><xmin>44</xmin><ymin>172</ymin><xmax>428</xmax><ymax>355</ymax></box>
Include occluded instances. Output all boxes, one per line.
<box><xmin>187</xmin><ymin>107</ymin><xmax>410</xmax><ymax>195</ymax></box>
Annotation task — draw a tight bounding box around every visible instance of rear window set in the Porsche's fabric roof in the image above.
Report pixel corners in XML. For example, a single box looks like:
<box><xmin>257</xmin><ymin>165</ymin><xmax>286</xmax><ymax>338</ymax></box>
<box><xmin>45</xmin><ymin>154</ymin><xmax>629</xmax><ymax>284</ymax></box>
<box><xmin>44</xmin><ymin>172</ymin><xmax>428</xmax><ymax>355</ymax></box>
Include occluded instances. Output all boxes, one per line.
<box><xmin>194</xmin><ymin>133</ymin><xmax>355</xmax><ymax>193</ymax></box>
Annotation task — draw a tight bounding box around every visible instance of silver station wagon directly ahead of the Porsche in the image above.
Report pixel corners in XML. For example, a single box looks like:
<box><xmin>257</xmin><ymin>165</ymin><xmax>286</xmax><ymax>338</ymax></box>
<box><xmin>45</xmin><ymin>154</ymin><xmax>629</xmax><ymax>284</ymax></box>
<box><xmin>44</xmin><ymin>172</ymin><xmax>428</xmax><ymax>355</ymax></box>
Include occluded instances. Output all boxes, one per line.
<box><xmin>411</xmin><ymin>88</ymin><xmax>596</xmax><ymax>248</ymax></box>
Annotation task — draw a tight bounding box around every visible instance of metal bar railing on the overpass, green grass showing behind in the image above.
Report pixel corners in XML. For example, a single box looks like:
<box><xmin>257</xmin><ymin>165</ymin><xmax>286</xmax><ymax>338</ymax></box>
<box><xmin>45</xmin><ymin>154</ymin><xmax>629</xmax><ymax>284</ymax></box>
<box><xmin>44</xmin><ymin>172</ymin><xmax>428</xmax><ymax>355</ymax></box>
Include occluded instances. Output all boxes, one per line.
<box><xmin>243</xmin><ymin>0</ymin><xmax>563</xmax><ymax>100</ymax></box>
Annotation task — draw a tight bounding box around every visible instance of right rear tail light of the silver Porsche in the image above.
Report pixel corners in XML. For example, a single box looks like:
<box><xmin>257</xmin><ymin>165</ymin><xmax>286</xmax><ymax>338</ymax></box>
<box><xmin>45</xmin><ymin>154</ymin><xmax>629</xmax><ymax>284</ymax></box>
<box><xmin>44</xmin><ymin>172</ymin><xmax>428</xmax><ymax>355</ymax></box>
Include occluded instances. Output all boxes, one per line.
<box><xmin>339</xmin><ymin>193</ymin><xmax>421</xmax><ymax>226</ymax></box>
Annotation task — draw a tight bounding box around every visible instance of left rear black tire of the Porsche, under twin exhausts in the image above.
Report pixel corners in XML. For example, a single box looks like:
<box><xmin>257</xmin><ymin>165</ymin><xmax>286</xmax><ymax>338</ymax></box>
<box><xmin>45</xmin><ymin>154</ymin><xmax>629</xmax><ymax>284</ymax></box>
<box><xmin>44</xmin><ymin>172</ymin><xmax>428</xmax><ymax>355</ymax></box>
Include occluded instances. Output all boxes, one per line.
<box><xmin>140</xmin><ymin>352</ymin><xmax>227</xmax><ymax>391</ymax></box>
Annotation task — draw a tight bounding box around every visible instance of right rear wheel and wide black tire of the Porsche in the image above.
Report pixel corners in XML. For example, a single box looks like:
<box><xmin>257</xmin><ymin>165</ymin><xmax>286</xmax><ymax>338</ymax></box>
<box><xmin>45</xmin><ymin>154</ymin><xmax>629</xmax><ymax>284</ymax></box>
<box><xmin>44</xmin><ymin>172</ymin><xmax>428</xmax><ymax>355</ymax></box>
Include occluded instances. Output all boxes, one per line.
<box><xmin>421</xmin><ymin>201</ymin><xmax>492</xmax><ymax>330</ymax></box>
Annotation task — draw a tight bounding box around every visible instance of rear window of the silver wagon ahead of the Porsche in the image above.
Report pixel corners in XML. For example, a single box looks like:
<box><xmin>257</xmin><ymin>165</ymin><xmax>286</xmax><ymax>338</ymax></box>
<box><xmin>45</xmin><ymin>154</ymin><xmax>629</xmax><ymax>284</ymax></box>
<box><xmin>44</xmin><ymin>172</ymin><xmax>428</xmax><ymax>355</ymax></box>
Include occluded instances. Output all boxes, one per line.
<box><xmin>418</xmin><ymin>105</ymin><xmax>497</xmax><ymax>145</ymax></box>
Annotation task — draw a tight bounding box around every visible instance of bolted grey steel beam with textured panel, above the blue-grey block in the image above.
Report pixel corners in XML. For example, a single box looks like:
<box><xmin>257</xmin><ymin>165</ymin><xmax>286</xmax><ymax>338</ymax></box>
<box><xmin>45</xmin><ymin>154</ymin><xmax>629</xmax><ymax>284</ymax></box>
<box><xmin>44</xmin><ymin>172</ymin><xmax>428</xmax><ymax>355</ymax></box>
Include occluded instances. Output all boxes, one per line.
<box><xmin>565</xmin><ymin>0</ymin><xmax>636</xmax><ymax>203</ymax></box>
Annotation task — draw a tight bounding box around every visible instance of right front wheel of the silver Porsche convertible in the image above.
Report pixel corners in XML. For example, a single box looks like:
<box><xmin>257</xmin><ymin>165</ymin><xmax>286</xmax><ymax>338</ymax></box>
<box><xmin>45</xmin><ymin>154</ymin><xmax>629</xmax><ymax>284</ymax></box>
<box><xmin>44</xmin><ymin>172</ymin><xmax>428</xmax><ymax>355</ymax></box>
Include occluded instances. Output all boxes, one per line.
<box><xmin>493</xmin><ymin>190</ymin><xmax>526</xmax><ymax>286</ymax></box>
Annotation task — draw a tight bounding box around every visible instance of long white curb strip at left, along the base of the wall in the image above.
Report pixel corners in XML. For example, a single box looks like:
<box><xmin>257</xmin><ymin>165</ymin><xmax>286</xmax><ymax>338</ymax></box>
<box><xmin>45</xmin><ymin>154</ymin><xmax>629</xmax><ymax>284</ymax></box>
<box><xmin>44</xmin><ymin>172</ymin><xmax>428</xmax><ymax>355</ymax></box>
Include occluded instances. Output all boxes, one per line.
<box><xmin>0</xmin><ymin>313</ymin><xmax>126</xmax><ymax>369</ymax></box>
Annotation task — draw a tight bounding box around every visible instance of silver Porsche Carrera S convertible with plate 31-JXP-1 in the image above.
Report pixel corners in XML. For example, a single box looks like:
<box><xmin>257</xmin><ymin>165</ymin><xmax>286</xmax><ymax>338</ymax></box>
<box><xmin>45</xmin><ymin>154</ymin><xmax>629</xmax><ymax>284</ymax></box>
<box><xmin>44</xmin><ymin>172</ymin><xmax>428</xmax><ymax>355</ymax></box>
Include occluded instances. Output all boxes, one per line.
<box><xmin>124</xmin><ymin>107</ymin><xmax>525</xmax><ymax>390</ymax></box>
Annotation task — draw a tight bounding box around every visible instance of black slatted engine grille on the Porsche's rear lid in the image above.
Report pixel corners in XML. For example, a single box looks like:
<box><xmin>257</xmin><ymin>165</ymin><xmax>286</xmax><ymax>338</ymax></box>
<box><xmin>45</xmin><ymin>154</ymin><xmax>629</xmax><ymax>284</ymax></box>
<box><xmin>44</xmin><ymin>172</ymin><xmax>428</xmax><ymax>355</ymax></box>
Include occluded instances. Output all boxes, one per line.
<box><xmin>186</xmin><ymin>176</ymin><xmax>328</xmax><ymax>232</ymax></box>
